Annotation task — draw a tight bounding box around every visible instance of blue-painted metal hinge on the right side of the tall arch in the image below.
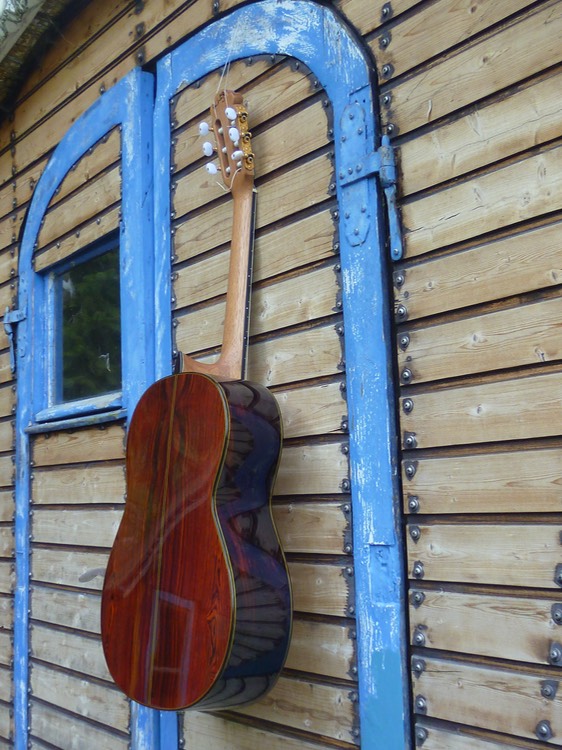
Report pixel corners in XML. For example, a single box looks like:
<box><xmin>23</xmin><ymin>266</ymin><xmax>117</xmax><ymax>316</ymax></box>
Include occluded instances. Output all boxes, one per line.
<box><xmin>338</xmin><ymin>102</ymin><xmax>403</xmax><ymax>261</ymax></box>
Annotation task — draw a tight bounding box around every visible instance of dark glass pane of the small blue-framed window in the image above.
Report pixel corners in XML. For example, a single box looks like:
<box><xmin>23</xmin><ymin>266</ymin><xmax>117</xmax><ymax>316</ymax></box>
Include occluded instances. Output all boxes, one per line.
<box><xmin>56</xmin><ymin>248</ymin><xmax>121</xmax><ymax>401</ymax></box>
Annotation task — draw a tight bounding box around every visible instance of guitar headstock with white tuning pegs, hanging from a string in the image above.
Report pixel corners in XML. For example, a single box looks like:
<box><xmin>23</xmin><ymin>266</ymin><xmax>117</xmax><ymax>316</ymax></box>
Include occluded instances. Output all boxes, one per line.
<box><xmin>199</xmin><ymin>90</ymin><xmax>254</xmax><ymax>191</ymax></box>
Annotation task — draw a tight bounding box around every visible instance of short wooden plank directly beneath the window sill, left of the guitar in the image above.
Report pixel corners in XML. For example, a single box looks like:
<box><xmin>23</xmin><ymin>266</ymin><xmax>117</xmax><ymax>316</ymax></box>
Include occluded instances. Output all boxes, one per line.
<box><xmin>33</xmin><ymin>425</ymin><xmax>125</xmax><ymax>466</ymax></box>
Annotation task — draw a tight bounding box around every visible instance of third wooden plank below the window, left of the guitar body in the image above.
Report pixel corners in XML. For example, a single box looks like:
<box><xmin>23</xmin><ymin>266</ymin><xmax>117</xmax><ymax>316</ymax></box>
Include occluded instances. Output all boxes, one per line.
<box><xmin>32</xmin><ymin>508</ymin><xmax>123</xmax><ymax>548</ymax></box>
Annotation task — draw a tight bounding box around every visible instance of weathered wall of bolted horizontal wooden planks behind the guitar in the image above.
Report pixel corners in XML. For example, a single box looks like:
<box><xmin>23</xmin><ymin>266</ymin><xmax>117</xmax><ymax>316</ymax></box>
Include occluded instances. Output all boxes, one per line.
<box><xmin>0</xmin><ymin>0</ymin><xmax>562</xmax><ymax>750</ymax></box>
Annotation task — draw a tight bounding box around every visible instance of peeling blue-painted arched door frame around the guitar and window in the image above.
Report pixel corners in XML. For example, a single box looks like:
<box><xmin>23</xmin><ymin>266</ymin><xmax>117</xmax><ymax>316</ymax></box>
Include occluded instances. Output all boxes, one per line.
<box><xmin>14</xmin><ymin>0</ymin><xmax>410</xmax><ymax>750</ymax></box>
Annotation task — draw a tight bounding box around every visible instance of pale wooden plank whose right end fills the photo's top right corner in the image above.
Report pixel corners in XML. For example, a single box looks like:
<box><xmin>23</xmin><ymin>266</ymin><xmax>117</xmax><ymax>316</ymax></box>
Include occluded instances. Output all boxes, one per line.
<box><xmin>383</xmin><ymin>1</ymin><xmax>562</xmax><ymax>133</ymax></box>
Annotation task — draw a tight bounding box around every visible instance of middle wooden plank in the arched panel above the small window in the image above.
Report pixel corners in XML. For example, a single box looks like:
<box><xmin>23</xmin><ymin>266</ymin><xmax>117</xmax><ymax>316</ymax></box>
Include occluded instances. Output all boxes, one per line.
<box><xmin>37</xmin><ymin>165</ymin><xmax>121</xmax><ymax>249</ymax></box>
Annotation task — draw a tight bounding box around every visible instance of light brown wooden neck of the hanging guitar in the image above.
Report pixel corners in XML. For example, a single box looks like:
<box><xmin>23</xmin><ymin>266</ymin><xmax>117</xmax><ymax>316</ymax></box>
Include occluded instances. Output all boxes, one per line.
<box><xmin>180</xmin><ymin>180</ymin><xmax>256</xmax><ymax>380</ymax></box>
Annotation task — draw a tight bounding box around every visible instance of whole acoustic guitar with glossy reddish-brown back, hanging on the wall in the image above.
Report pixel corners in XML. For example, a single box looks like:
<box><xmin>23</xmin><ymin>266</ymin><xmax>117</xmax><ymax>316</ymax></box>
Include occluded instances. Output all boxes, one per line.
<box><xmin>101</xmin><ymin>91</ymin><xmax>292</xmax><ymax>710</ymax></box>
